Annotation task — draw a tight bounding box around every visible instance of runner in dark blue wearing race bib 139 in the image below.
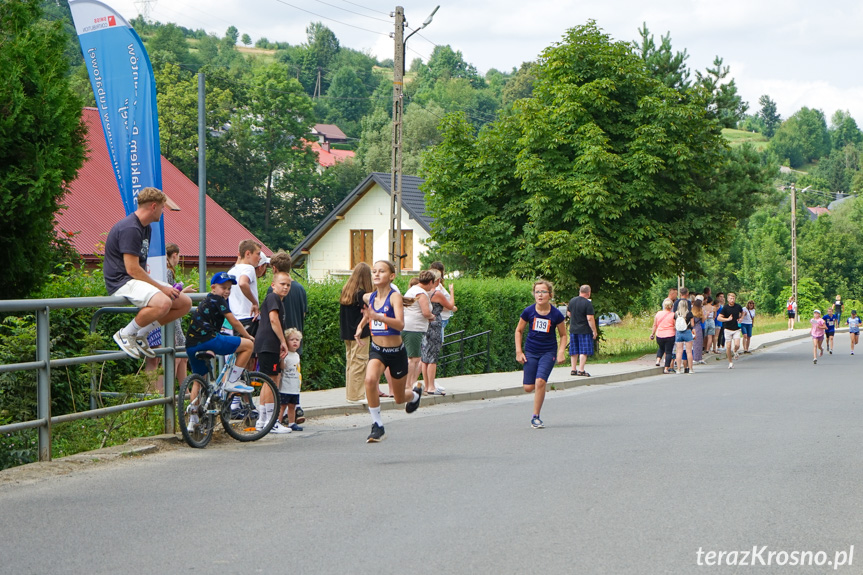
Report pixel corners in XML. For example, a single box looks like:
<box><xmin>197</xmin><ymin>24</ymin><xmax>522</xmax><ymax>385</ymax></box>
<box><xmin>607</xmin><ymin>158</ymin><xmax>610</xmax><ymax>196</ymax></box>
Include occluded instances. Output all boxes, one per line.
<box><xmin>515</xmin><ymin>280</ymin><xmax>566</xmax><ymax>429</ymax></box>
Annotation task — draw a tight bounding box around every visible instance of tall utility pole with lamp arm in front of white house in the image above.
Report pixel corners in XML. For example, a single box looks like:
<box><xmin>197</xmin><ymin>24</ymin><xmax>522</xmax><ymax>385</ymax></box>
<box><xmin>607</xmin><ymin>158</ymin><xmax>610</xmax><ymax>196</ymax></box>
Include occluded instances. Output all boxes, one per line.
<box><xmin>390</xmin><ymin>6</ymin><xmax>440</xmax><ymax>275</ymax></box>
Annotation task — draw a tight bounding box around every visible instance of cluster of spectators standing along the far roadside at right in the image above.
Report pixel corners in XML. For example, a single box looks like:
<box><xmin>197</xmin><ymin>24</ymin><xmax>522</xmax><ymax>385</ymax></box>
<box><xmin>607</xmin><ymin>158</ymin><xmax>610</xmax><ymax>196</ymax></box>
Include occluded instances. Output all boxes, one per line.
<box><xmin>650</xmin><ymin>287</ymin><xmax>755</xmax><ymax>374</ymax></box>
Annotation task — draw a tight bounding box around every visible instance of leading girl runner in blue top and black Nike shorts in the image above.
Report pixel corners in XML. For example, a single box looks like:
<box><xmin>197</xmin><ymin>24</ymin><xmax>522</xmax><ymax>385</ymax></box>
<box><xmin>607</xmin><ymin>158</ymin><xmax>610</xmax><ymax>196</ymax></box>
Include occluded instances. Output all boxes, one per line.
<box><xmin>355</xmin><ymin>260</ymin><xmax>422</xmax><ymax>443</ymax></box>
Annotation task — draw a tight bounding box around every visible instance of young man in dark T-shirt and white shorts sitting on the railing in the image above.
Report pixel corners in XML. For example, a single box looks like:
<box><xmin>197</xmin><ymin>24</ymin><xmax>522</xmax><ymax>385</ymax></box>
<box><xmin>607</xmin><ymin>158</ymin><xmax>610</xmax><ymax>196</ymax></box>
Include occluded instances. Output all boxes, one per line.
<box><xmin>103</xmin><ymin>188</ymin><xmax>192</xmax><ymax>359</ymax></box>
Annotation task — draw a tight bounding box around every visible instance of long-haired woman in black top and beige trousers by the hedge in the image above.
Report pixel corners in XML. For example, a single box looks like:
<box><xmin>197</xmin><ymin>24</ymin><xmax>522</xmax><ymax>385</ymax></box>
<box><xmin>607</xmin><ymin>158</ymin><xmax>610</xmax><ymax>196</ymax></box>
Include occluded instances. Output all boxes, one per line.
<box><xmin>339</xmin><ymin>262</ymin><xmax>374</xmax><ymax>401</ymax></box>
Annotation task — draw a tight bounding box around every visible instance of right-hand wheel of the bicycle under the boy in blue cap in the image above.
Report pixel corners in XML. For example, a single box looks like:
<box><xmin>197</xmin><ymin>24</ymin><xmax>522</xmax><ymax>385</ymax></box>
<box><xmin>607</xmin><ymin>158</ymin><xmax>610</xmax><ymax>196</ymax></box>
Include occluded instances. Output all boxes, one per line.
<box><xmin>219</xmin><ymin>371</ymin><xmax>279</xmax><ymax>441</ymax></box>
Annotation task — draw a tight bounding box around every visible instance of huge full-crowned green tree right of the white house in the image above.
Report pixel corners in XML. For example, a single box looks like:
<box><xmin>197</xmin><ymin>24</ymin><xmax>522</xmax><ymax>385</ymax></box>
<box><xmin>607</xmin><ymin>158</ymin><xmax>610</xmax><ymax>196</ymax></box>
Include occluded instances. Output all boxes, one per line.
<box><xmin>424</xmin><ymin>22</ymin><xmax>769</xmax><ymax>300</ymax></box>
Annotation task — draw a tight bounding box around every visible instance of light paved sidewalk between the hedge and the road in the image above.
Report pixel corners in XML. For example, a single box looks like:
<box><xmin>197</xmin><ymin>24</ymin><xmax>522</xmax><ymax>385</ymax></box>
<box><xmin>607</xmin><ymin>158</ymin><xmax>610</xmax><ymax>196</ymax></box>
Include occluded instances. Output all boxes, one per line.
<box><xmin>300</xmin><ymin>328</ymin><xmax>816</xmax><ymax>418</ymax></box>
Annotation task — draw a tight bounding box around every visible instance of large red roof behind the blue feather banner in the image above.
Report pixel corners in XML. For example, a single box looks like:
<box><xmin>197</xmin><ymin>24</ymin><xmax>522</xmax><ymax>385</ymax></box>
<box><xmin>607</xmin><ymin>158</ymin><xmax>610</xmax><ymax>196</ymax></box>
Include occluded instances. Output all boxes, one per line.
<box><xmin>55</xmin><ymin>108</ymin><xmax>272</xmax><ymax>265</ymax></box>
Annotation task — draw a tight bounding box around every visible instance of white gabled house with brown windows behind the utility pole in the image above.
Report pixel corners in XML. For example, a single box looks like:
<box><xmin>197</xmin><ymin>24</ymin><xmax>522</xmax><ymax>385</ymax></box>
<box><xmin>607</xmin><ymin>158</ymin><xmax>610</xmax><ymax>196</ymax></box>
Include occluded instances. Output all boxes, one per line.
<box><xmin>291</xmin><ymin>172</ymin><xmax>432</xmax><ymax>281</ymax></box>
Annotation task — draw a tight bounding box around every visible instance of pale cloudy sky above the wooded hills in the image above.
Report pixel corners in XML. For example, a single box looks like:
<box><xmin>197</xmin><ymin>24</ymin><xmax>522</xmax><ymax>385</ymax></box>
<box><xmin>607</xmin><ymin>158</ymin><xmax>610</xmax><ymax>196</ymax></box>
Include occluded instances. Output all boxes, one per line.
<box><xmin>103</xmin><ymin>0</ymin><xmax>863</xmax><ymax>122</ymax></box>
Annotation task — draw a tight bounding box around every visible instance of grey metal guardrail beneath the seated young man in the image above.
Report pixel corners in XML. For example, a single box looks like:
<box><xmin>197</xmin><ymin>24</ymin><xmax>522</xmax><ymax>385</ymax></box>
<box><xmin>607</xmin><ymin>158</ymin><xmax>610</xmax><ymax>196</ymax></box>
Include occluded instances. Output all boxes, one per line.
<box><xmin>0</xmin><ymin>294</ymin><xmax>206</xmax><ymax>461</ymax></box>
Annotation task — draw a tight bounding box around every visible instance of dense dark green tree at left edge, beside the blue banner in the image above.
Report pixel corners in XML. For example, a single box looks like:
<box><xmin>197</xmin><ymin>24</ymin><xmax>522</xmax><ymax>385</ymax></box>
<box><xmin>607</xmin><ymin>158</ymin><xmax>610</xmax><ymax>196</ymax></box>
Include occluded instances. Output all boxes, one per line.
<box><xmin>0</xmin><ymin>0</ymin><xmax>84</xmax><ymax>298</ymax></box>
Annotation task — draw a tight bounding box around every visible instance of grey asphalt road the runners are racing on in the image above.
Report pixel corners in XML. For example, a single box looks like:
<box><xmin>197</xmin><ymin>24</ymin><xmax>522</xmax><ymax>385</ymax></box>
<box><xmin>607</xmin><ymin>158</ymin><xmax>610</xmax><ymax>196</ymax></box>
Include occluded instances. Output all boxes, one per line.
<box><xmin>0</xmin><ymin>341</ymin><xmax>863</xmax><ymax>575</ymax></box>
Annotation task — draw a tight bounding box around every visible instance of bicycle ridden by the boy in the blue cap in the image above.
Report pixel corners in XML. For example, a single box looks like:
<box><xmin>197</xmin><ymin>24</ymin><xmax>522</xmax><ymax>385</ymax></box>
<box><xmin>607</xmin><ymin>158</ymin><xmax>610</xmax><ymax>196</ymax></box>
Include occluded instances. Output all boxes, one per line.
<box><xmin>176</xmin><ymin>351</ymin><xmax>279</xmax><ymax>448</ymax></box>
